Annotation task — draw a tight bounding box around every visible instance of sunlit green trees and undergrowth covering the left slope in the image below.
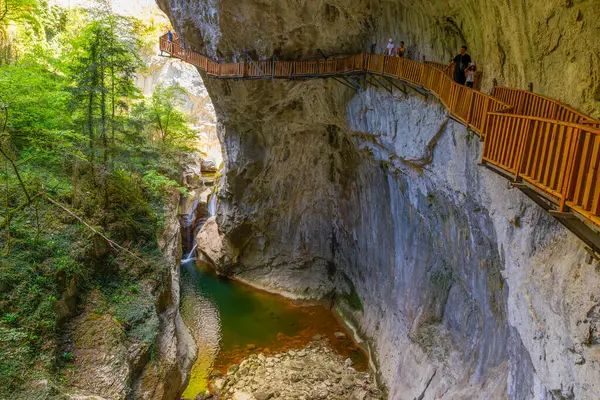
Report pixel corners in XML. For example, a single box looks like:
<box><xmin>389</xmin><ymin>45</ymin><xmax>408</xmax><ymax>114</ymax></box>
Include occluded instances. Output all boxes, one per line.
<box><xmin>0</xmin><ymin>0</ymin><xmax>193</xmax><ymax>398</ymax></box>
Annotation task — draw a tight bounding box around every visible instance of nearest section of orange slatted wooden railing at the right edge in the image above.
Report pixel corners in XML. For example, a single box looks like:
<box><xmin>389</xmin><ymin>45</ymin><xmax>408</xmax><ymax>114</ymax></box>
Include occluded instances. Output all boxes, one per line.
<box><xmin>483</xmin><ymin>113</ymin><xmax>600</xmax><ymax>226</ymax></box>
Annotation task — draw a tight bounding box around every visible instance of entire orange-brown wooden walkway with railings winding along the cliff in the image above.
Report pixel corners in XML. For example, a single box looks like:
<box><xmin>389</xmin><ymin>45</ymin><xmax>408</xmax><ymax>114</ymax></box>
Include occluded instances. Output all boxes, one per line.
<box><xmin>160</xmin><ymin>36</ymin><xmax>600</xmax><ymax>257</ymax></box>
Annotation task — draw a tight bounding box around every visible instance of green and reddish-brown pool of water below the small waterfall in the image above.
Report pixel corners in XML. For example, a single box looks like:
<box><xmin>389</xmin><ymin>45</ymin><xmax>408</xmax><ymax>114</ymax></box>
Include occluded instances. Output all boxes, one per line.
<box><xmin>181</xmin><ymin>261</ymin><xmax>367</xmax><ymax>398</ymax></box>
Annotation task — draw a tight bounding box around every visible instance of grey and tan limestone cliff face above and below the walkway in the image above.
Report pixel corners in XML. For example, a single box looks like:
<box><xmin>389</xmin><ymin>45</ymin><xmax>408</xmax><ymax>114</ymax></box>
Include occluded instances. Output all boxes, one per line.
<box><xmin>159</xmin><ymin>0</ymin><xmax>600</xmax><ymax>399</ymax></box>
